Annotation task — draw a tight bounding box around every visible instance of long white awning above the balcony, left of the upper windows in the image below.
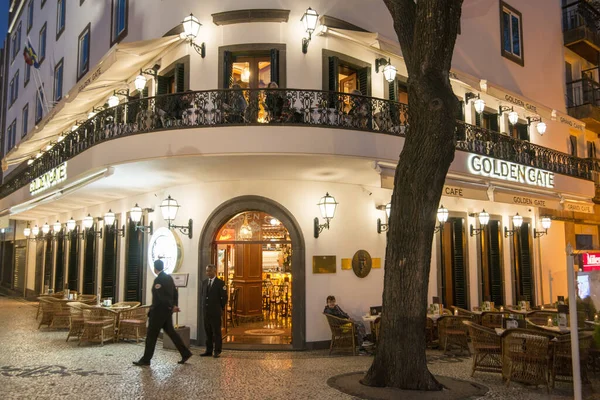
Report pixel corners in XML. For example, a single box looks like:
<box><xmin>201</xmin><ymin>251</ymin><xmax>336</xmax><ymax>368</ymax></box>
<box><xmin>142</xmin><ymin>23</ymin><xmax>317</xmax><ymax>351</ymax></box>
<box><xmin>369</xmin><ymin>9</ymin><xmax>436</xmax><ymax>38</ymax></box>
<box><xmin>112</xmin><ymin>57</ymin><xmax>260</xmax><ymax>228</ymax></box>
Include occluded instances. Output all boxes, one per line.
<box><xmin>2</xmin><ymin>35</ymin><xmax>181</xmax><ymax>170</ymax></box>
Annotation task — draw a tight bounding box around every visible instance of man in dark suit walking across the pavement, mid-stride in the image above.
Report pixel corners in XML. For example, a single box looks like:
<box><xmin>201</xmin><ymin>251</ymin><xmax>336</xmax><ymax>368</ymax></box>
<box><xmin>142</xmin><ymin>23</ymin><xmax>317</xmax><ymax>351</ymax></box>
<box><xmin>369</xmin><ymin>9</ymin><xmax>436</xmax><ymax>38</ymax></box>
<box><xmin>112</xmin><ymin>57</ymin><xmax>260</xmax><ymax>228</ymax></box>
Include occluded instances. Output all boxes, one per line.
<box><xmin>133</xmin><ymin>260</ymin><xmax>192</xmax><ymax>366</ymax></box>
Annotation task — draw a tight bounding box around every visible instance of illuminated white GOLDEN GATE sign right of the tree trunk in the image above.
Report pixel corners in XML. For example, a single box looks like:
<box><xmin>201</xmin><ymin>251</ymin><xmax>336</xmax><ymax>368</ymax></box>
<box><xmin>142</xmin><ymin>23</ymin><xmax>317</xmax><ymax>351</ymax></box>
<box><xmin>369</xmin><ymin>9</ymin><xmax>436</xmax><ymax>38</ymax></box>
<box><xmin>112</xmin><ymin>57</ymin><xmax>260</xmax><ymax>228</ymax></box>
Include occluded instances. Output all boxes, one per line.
<box><xmin>468</xmin><ymin>154</ymin><xmax>554</xmax><ymax>188</ymax></box>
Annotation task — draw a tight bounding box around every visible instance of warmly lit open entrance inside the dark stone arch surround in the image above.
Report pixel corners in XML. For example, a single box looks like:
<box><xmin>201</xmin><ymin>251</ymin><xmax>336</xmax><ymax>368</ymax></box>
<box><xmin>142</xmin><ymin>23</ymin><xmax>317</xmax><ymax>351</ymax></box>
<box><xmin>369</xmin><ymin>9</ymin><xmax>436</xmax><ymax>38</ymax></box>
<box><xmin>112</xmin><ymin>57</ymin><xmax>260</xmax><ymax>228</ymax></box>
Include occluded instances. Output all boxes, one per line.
<box><xmin>212</xmin><ymin>211</ymin><xmax>293</xmax><ymax>345</ymax></box>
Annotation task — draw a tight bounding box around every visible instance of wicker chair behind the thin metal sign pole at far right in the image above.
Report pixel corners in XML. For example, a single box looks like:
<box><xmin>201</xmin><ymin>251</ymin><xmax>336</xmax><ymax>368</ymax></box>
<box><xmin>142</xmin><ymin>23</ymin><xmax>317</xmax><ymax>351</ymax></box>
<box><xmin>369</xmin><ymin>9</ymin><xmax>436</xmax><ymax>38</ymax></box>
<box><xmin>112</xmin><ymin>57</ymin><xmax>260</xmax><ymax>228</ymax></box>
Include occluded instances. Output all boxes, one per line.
<box><xmin>551</xmin><ymin>332</ymin><xmax>593</xmax><ymax>389</ymax></box>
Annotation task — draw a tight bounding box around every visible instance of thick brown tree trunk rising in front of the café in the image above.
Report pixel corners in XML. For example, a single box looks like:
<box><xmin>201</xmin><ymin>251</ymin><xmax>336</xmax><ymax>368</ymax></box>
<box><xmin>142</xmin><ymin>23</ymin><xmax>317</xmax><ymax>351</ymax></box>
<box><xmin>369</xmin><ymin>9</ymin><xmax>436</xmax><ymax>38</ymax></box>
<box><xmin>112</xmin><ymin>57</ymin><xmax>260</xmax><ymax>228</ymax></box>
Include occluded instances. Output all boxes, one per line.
<box><xmin>362</xmin><ymin>0</ymin><xmax>463</xmax><ymax>390</ymax></box>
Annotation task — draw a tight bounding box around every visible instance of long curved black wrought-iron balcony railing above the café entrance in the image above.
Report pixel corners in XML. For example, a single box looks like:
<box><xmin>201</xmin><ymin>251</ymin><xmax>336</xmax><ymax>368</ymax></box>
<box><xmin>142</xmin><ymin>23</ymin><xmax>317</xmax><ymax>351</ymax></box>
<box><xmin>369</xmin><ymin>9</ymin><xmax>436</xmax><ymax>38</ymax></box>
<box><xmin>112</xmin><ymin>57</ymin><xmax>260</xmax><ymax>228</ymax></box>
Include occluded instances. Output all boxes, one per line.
<box><xmin>0</xmin><ymin>89</ymin><xmax>593</xmax><ymax>198</ymax></box>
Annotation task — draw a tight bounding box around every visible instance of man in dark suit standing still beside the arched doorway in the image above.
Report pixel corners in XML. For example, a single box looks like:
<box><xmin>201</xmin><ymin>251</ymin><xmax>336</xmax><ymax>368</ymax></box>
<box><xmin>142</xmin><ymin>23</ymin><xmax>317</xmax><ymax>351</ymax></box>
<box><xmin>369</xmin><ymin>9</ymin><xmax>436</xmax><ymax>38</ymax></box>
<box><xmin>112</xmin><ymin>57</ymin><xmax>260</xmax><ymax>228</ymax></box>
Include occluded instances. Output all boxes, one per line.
<box><xmin>200</xmin><ymin>264</ymin><xmax>227</xmax><ymax>358</ymax></box>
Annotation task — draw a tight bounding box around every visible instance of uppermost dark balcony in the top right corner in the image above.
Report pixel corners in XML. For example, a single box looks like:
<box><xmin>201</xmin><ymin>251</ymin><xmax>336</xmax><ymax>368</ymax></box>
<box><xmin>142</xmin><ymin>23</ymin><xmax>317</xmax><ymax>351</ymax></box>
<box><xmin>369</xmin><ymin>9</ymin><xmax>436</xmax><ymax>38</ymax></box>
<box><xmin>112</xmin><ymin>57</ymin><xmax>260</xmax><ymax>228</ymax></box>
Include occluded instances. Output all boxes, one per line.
<box><xmin>563</xmin><ymin>0</ymin><xmax>600</xmax><ymax>64</ymax></box>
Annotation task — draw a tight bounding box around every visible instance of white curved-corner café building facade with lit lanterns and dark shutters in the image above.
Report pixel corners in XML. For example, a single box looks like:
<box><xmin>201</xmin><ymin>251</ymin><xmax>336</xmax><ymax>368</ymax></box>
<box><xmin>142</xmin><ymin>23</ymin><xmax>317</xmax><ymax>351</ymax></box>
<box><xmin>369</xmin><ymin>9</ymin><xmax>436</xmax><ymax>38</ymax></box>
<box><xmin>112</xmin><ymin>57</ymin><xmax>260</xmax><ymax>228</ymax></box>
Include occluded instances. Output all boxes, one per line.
<box><xmin>0</xmin><ymin>0</ymin><xmax>597</xmax><ymax>348</ymax></box>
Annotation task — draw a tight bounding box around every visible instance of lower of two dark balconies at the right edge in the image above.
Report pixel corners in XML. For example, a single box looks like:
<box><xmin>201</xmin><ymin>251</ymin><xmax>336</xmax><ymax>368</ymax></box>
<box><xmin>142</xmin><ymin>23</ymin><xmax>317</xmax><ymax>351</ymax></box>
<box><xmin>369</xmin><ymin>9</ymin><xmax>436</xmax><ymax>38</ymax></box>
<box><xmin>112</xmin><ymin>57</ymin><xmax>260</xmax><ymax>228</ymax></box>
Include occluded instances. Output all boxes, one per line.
<box><xmin>566</xmin><ymin>76</ymin><xmax>600</xmax><ymax>134</ymax></box>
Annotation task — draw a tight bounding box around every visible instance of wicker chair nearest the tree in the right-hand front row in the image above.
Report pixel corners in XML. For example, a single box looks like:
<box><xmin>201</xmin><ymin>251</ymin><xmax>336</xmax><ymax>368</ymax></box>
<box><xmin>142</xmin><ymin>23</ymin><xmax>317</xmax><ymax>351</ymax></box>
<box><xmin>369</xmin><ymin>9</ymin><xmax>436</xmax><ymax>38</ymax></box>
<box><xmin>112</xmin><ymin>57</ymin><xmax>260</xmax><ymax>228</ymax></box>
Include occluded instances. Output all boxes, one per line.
<box><xmin>463</xmin><ymin>321</ymin><xmax>502</xmax><ymax>376</ymax></box>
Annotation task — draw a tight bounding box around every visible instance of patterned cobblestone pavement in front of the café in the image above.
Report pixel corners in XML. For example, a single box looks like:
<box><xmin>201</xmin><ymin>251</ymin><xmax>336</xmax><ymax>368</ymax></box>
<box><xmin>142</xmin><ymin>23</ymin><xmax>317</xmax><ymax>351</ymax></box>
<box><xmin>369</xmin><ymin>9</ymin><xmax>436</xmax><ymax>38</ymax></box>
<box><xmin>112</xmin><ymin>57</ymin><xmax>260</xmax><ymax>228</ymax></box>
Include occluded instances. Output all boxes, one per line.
<box><xmin>0</xmin><ymin>297</ymin><xmax>591</xmax><ymax>400</ymax></box>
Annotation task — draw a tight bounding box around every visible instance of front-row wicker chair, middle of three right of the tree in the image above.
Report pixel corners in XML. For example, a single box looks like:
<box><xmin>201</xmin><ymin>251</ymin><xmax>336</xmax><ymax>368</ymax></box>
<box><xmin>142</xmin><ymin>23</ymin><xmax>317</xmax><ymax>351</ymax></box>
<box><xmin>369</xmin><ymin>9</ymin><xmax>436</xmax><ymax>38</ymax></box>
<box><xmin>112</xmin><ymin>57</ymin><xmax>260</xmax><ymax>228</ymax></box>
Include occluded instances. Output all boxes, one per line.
<box><xmin>502</xmin><ymin>329</ymin><xmax>552</xmax><ymax>392</ymax></box>
